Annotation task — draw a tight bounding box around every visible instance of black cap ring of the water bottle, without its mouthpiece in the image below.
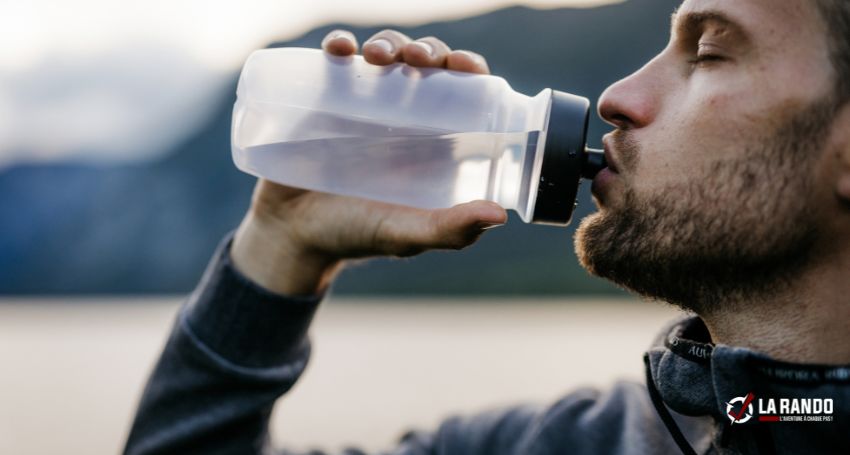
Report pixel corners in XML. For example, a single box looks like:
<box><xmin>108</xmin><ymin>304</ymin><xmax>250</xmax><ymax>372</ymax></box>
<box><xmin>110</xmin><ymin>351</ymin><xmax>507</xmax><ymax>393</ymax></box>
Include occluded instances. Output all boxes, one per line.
<box><xmin>531</xmin><ymin>90</ymin><xmax>590</xmax><ymax>226</ymax></box>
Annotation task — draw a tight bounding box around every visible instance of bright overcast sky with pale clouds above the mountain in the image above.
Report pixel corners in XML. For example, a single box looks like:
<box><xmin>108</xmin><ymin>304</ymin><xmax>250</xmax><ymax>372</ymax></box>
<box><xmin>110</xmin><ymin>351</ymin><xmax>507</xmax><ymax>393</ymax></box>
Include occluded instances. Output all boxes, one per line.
<box><xmin>0</xmin><ymin>0</ymin><xmax>617</xmax><ymax>168</ymax></box>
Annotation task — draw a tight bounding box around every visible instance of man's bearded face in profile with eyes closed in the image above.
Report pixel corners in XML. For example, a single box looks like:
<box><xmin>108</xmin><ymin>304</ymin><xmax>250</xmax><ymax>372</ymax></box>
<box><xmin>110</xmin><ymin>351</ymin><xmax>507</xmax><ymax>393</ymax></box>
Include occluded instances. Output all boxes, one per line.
<box><xmin>576</xmin><ymin>0</ymin><xmax>836</xmax><ymax>313</ymax></box>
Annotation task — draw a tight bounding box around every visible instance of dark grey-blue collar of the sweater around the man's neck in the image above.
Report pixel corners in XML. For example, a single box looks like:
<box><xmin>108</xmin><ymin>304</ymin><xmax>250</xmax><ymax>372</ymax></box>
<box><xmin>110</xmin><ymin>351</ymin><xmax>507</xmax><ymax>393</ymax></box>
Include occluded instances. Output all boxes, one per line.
<box><xmin>647</xmin><ymin>316</ymin><xmax>850</xmax><ymax>453</ymax></box>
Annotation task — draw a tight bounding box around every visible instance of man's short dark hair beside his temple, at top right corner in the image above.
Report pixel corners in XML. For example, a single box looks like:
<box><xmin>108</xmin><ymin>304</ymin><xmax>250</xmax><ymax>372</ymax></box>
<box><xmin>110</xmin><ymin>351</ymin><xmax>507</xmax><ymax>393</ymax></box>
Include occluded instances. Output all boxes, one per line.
<box><xmin>817</xmin><ymin>0</ymin><xmax>850</xmax><ymax>105</ymax></box>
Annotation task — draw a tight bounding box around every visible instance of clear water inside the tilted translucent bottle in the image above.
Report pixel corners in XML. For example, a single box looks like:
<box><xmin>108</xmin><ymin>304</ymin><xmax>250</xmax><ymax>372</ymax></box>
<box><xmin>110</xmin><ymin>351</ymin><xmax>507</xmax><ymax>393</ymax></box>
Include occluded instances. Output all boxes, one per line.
<box><xmin>240</xmin><ymin>131</ymin><xmax>542</xmax><ymax>214</ymax></box>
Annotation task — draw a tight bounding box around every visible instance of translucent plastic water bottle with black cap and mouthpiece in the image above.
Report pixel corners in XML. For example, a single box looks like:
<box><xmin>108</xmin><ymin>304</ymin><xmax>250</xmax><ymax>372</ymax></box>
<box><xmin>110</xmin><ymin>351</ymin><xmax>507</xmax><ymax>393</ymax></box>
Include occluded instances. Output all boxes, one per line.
<box><xmin>231</xmin><ymin>48</ymin><xmax>605</xmax><ymax>225</ymax></box>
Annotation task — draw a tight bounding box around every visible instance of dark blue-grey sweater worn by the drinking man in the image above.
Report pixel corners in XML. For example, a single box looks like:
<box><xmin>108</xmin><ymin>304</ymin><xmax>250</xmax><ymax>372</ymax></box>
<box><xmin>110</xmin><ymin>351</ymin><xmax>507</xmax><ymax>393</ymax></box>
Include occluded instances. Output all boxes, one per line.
<box><xmin>125</xmin><ymin>236</ymin><xmax>850</xmax><ymax>455</ymax></box>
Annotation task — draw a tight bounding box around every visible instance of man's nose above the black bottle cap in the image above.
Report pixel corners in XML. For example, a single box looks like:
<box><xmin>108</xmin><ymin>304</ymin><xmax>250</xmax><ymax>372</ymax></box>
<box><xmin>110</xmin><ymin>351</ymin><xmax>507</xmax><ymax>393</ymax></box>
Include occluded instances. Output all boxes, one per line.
<box><xmin>598</xmin><ymin>65</ymin><xmax>659</xmax><ymax>129</ymax></box>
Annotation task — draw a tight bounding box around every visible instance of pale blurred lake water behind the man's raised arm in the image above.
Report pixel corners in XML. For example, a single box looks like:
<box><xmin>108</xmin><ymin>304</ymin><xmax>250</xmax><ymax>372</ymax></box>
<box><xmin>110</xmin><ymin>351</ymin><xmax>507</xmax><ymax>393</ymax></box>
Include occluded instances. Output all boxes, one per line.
<box><xmin>0</xmin><ymin>296</ymin><xmax>680</xmax><ymax>455</ymax></box>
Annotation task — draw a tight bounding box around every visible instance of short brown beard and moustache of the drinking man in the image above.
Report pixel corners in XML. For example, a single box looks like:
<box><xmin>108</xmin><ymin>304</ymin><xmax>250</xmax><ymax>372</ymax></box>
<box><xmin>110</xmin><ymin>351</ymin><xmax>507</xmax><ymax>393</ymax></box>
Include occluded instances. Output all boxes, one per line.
<box><xmin>575</xmin><ymin>97</ymin><xmax>836</xmax><ymax>315</ymax></box>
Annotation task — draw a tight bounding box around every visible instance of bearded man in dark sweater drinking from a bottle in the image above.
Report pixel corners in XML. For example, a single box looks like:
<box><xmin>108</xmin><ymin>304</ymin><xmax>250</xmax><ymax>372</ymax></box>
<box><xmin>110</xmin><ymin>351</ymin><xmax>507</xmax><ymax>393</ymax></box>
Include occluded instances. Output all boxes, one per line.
<box><xmin>126</xmin><ymin>0</ymin><xmax>850</xmax><ymax>454</ymax></box>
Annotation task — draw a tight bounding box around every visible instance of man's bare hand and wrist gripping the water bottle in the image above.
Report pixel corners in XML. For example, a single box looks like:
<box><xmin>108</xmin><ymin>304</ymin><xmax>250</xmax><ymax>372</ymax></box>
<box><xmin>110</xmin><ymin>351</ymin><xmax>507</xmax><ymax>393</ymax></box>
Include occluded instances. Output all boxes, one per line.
<box><xmin>231</xmin><ymin>30</ymin><xmax>507</xmax><ymax>295</ymax></box>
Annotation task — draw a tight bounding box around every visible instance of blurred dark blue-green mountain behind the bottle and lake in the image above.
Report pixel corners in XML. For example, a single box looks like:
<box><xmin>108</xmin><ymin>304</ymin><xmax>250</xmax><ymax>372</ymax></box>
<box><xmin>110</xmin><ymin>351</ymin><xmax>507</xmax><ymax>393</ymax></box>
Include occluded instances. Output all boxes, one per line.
<box><xmin>0</xmin><ymin>0</ymin><xmax>679</xmax><ymax>294</ymax></box>
